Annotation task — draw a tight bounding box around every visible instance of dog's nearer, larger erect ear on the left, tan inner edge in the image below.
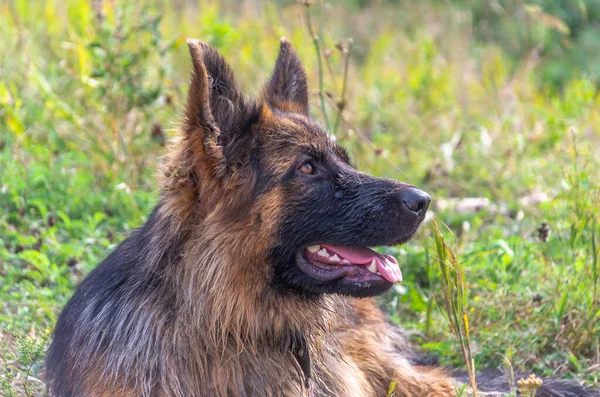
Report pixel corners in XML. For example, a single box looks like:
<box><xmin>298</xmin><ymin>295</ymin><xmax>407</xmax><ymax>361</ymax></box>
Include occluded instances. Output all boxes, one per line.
<box><xmin>183</xmin><ymin>39</ymin><xmax>248</xmax><ymax>170</ymax></box>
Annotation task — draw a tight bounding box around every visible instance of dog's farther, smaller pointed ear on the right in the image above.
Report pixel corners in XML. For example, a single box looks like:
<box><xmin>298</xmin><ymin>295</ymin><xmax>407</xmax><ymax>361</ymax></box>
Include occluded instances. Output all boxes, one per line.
<box><xmin>263</xmin><ymin>37</ymin><xmax>309</xmax><ymax>115</ymax></box>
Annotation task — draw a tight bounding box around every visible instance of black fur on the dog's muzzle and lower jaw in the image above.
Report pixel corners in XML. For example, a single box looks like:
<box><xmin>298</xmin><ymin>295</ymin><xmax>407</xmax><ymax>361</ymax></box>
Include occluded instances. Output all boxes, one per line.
<box><xmin>272</xmin><ymin>125</ymin><xmax>429</xmax><ymax>297</ymax></box>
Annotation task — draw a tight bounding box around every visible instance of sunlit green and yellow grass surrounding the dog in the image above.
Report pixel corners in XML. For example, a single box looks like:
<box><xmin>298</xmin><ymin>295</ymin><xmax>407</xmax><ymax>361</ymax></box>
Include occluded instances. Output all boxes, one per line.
<box><xmin>0</xmin><ymin>0</ymin><xmax>600</xmax><ymax>395</ymax></box>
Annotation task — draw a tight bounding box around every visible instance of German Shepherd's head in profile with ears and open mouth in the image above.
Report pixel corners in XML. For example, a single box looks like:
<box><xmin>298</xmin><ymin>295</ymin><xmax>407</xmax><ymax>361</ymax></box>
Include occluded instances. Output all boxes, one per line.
<box><xmin>165</xmin><ymin>39</ymin><xmax>429</xmax><ymax>297</ymax></box>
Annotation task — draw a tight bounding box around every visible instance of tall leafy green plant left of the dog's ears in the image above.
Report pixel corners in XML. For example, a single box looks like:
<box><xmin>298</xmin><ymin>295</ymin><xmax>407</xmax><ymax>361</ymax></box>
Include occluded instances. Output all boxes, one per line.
<box><xmin>68</xmin><ymin>1</ymin><xmax>178</xmax><ymax>183</ymax></box>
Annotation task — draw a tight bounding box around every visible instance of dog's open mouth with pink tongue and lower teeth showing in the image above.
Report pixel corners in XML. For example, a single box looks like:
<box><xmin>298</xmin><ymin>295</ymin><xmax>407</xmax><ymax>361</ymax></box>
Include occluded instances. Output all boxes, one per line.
<box><xmin>297</xmin><ymin>244</ymin><xmax>402</xmax><ymax>284</ymax></box>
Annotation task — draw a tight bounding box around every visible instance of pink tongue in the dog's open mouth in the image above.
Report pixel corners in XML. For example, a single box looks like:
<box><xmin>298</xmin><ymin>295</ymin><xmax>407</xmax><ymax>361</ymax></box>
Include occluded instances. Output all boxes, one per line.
<box><xmin>321</xmin><ymin>244</ymin><xmax>402</xmax><ymax>283</ymax></box>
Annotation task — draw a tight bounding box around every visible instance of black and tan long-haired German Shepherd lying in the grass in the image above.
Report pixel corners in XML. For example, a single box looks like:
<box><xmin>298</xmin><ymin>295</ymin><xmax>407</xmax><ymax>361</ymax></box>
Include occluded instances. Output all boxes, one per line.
<box><xmin>46</xmin><ymin>39</ymin><xmax>595</xmax><ymax>397</ymax></box>
